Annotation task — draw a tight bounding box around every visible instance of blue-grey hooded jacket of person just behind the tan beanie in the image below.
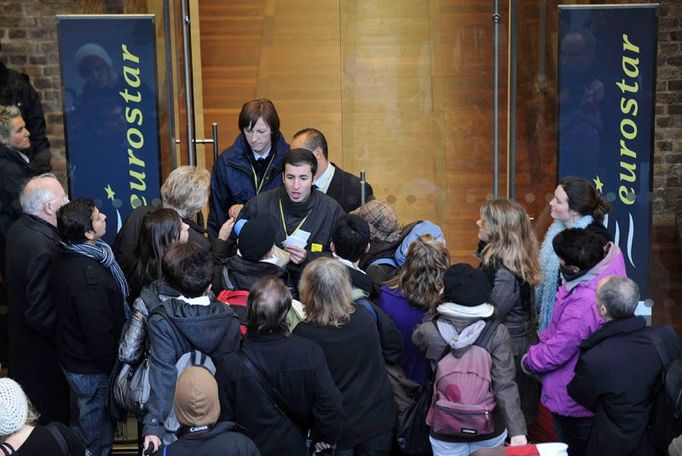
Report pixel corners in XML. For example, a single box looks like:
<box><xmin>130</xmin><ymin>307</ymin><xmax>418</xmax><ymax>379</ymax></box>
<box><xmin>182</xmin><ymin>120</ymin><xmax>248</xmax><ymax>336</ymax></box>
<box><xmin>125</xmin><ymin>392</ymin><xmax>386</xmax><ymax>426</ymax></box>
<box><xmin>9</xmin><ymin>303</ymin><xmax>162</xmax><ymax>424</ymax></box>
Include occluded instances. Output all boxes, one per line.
<box><xmin>143</xmin><ymin>298</ymin><xmax>239</xmax><ymax>438</ymax></box>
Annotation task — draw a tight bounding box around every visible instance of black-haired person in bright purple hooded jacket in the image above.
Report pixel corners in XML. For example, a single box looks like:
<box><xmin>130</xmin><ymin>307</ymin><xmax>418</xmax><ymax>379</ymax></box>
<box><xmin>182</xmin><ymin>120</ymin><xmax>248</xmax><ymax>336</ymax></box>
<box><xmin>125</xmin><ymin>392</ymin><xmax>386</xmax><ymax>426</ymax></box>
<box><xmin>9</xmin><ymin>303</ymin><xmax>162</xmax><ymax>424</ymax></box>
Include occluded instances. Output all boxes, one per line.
<box><xmin>521</xmin><ymin>228</ymin><xmax>625</xmax><ymax>456</ymax></box>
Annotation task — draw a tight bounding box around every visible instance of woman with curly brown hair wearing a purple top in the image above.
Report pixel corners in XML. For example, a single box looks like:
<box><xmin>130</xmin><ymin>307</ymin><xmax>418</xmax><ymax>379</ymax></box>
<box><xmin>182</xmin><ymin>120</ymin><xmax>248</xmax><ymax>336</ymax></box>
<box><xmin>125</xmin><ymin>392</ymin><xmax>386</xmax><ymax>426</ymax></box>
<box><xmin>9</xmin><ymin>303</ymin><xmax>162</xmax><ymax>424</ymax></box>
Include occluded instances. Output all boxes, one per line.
<box><xmin>379</xmin><ymin>235</ymin><xmax>450</xmax><ymax>384</ymax></box>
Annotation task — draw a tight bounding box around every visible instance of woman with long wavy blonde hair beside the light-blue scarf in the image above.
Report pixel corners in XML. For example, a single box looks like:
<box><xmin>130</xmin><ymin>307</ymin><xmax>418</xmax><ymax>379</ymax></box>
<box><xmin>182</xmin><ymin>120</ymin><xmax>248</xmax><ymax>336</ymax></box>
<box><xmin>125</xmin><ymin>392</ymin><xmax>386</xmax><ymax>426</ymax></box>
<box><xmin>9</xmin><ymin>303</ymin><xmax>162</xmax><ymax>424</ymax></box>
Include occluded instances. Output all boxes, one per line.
<box><xmin>476</xmin><ymin>199</ymin><xmax>540</xmax><ymax>425</ymax></box>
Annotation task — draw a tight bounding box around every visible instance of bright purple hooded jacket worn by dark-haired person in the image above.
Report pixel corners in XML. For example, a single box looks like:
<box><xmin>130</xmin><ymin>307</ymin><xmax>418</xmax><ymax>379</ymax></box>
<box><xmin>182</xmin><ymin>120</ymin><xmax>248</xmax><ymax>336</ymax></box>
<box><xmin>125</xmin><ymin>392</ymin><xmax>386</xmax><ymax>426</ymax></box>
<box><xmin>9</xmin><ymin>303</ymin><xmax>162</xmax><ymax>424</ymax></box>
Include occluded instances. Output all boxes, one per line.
<box><xmin>522</xmin><ymin>243</ymin><xmax>625</xmax><ymax>417</ymax></box>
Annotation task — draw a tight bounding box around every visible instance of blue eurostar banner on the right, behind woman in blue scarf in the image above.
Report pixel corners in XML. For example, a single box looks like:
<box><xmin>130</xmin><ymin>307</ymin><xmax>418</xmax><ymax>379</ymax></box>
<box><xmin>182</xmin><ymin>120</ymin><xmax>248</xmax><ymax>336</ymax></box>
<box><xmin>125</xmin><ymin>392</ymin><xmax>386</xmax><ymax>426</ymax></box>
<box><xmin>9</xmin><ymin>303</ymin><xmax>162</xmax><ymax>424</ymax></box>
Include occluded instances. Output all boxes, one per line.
<box><xmin>558</xmin><ymin>5</ymin><xmax>658</xmax><ymax>299</ymax></box>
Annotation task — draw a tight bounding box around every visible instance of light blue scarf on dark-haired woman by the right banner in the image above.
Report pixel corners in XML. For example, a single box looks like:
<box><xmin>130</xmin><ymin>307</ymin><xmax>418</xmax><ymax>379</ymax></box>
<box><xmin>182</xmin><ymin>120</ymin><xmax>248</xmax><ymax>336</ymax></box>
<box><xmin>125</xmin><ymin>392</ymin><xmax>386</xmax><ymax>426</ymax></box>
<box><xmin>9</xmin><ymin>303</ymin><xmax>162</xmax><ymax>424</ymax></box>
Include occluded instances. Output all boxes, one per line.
<box><xmin>535</xmin><ymin>215</ymin><xmax>594</xmax><ymax>334</ymax></box>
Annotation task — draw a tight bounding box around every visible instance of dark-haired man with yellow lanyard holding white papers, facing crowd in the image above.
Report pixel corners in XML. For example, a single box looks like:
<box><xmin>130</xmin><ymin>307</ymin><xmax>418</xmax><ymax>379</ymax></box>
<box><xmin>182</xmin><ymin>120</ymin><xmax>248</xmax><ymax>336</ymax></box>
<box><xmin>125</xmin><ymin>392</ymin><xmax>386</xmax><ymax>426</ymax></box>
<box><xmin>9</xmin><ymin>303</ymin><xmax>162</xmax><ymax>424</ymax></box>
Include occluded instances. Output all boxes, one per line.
<box><xmin>239</xmin><ymin>149</ymin><xmax>344</xmax><ymax>278</ymax></box>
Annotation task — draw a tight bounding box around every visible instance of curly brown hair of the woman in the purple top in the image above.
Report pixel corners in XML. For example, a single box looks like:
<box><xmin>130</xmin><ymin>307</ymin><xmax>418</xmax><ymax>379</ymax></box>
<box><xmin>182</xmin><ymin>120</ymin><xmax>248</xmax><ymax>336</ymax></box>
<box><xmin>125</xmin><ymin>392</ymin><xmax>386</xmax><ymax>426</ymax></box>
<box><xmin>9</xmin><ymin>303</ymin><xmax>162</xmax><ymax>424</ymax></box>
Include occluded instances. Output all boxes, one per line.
<box><xmin>386</xmin><ymin>234</ymin><xmax>450</xmax><ymax>309</ymax></box>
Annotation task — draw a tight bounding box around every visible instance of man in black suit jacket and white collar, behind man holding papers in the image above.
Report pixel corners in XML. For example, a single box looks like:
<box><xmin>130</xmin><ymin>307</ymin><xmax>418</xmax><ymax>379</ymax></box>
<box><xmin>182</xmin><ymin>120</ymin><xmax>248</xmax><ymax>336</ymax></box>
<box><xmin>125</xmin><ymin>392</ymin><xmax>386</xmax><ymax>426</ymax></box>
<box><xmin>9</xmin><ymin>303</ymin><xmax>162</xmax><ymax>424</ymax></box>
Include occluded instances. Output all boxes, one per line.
<box><xmin>291</xmin><ymin>128</ymin><xmax>374</xmax><ymax>213</ymax></box>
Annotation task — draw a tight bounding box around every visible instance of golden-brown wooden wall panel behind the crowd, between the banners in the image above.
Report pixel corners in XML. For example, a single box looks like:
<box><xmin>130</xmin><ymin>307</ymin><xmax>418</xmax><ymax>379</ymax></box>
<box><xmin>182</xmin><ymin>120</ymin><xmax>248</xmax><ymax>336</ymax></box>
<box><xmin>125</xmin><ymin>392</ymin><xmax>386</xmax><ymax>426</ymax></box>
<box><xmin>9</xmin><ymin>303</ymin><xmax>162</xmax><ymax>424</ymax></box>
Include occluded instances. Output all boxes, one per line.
<box><xmin>200</xmin><ymin>0</ymin><xmax>506</xmax><ymax>262</ymax></box>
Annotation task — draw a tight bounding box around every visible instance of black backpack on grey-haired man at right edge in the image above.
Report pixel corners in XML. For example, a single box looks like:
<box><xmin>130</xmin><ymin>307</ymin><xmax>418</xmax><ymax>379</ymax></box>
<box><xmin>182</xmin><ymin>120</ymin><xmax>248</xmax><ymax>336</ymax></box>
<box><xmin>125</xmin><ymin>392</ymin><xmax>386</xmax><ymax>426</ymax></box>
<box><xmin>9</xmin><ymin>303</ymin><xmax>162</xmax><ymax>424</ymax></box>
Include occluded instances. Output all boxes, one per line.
<box><xmin>648</xmin><ymin>325</ymin><xmax>682</xmax><ymax>454</ymax></box>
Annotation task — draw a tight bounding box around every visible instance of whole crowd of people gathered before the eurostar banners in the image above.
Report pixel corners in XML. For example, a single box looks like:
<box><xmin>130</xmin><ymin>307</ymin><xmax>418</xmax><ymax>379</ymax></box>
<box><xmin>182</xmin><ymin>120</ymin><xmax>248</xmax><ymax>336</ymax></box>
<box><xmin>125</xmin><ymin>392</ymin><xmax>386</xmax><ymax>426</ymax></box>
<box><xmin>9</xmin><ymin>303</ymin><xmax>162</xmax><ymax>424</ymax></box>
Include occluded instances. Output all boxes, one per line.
<box><xmin>0</xmin><ymin>99</ymin><xmax>679</xmax><ymax>456</ymax></box>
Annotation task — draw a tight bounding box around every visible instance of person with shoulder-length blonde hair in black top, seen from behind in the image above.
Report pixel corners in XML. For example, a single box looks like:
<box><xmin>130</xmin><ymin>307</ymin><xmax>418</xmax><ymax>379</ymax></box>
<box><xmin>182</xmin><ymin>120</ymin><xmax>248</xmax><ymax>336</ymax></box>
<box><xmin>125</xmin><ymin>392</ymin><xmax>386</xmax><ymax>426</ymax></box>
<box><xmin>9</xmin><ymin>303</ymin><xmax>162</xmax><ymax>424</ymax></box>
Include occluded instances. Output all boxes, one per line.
<box><xmin>294</xmin><ymin>257</ymin><xmax>396</xmax><ymax>456</ymax></box>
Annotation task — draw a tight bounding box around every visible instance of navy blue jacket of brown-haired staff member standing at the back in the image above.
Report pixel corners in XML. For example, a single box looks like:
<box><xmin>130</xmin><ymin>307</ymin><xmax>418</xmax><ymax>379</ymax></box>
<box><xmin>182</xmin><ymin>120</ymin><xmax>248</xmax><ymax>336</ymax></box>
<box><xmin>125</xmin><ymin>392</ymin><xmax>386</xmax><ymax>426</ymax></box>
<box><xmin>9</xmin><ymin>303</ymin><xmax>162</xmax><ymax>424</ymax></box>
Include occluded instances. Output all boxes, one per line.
<box><xmin>208</xmin><ymin>133</ymin><xmax>289</xmax><ymax>237</ymax></box>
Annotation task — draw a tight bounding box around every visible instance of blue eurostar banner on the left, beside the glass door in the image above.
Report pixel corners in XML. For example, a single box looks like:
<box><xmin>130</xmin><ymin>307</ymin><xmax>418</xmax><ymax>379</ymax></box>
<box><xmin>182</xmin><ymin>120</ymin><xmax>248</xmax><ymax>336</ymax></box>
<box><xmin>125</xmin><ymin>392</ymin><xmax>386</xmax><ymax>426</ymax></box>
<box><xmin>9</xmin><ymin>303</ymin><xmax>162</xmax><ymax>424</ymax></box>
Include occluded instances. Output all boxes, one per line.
<box><xmin>57</xmin><ymin>15</ymin><xmax>161</xmax><ymax>243</ymax></box>
